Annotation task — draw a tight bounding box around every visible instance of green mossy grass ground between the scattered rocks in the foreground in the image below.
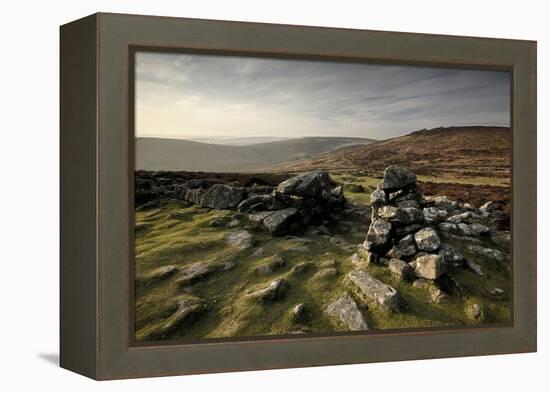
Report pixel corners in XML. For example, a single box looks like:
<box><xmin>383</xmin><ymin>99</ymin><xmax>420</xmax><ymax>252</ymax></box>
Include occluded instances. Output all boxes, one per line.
<box><xmin>135</xmin><ymin>176</ymin><xmax>511</xmax><ymax>341</ymax></box>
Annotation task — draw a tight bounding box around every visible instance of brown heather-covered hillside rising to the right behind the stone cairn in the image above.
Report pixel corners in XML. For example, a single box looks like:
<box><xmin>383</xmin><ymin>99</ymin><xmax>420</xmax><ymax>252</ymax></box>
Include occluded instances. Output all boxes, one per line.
<box><xmin>264</xmin><ymin>126</ymin><xmax>512</xmax><ymax>179</ymax></box>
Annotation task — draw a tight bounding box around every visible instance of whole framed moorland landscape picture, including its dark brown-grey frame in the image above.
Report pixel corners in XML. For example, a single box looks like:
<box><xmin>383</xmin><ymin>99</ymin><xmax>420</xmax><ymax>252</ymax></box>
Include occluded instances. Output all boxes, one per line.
<box><xmin>61</xmin><ymin>13</ymin><xmax>536</xmax><ymax>379</ymax></box>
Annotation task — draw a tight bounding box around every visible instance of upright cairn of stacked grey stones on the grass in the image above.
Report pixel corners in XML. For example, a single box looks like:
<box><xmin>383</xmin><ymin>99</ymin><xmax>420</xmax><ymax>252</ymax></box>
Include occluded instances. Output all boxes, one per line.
<box><xmin>355</xmin><ymin>165</ymin><xmax>452</xmax><ymax>280</ymax></box>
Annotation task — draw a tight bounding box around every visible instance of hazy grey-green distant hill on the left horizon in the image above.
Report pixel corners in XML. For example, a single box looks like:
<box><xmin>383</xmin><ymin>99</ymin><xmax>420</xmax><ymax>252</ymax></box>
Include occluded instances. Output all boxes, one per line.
<box><xmin>136</xmin><ymin>137</ymin><xmax>373</xmax><ymax>172</ymax></box>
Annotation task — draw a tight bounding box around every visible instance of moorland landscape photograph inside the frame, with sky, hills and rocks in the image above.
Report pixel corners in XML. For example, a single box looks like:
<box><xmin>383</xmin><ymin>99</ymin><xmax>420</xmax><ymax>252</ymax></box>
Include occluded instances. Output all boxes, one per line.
<box><xmin>133</xmin><ymin>51</ymin><xmax>513</xmax><ymax>343</ymax></box>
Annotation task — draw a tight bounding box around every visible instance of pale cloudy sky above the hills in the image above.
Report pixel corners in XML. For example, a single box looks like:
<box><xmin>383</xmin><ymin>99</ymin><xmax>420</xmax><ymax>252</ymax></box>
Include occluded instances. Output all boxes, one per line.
<box><xmin>135</xmin><ymin>52</ymin><xmax>510</xmax><ymax>139</ymax></box>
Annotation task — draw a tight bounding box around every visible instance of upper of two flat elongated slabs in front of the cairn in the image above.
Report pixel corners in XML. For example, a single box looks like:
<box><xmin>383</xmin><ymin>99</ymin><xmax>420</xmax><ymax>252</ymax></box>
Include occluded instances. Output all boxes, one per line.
<box><xmin>346</xmin><ymin>270</ymin><xmax>401</xmax><ymax>311</ymax></box>
